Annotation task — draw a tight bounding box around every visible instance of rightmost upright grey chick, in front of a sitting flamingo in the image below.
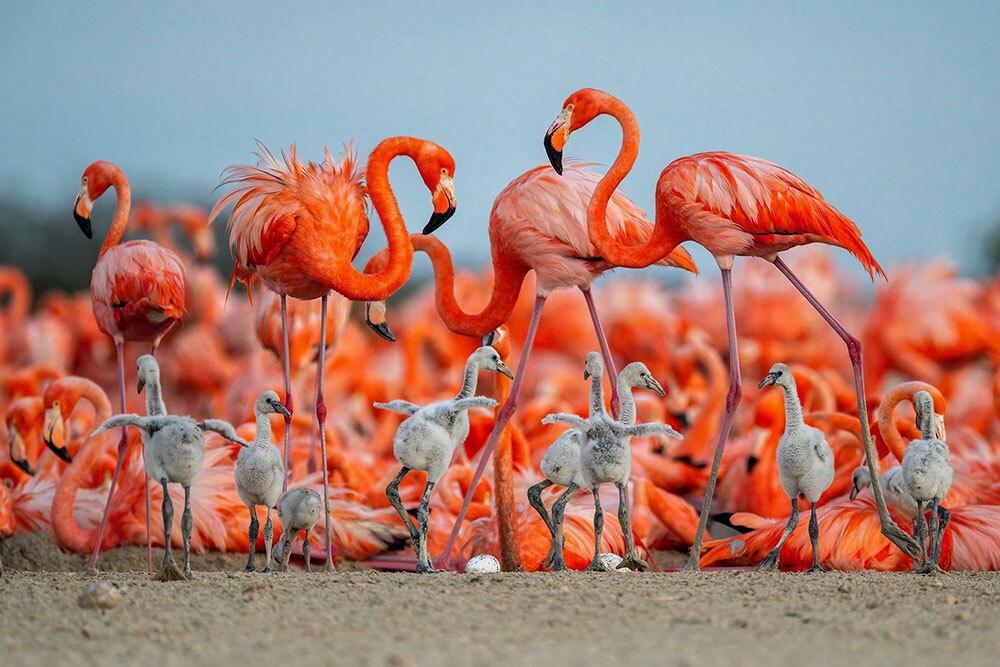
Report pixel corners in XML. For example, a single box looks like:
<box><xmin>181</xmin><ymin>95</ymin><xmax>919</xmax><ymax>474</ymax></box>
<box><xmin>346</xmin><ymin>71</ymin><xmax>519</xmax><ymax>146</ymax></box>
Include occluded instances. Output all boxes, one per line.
<box><xmin>901</xmin><ymin>391</ymin><xmax>954</xmax><ymax>573</ymax></box>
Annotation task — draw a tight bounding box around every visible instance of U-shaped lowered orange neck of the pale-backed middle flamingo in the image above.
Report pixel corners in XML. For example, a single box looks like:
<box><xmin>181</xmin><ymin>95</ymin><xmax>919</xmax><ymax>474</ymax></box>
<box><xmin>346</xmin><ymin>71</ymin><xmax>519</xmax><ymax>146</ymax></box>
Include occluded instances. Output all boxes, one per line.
<box><xmin>365</xmin><ymin>234</ymin><xmax>529</xmax><ymax>338</ymax></box>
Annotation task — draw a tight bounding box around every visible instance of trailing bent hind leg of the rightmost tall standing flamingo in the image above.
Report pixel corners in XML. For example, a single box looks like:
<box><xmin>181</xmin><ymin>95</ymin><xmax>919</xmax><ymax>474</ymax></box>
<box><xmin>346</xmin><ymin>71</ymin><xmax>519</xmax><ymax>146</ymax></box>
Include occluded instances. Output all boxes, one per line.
<box><xmin>774</xmin><ymin>257</ymin><xmax>920</xmax><ymax>558</ymax></box>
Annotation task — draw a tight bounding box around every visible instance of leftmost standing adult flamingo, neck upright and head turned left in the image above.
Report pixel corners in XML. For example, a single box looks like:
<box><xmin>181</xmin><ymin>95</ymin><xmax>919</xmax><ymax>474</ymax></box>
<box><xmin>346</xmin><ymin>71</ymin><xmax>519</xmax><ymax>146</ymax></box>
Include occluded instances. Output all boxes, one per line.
<box><xmin>73</xmin><ymin>160</ymin><xmax>184</xmax><ymax>571</ymax></box>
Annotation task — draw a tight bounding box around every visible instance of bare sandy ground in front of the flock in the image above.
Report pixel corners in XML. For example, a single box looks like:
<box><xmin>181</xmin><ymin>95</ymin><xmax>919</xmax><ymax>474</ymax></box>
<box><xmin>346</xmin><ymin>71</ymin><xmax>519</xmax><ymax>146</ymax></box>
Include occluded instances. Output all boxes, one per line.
<box><xmin>0</xmin><ymin>537</ymin><xmax>1000</xmax><ymax>667</ymax></box>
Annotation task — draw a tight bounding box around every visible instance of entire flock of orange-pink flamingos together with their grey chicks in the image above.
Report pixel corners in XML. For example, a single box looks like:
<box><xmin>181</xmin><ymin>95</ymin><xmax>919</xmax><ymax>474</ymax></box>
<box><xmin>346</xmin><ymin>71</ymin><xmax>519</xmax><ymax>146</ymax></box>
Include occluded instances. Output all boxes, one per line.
<box><xmin>0</xmin><ymin>89</ymin><xmax>1000</xmax><ymax>578</ymax></box>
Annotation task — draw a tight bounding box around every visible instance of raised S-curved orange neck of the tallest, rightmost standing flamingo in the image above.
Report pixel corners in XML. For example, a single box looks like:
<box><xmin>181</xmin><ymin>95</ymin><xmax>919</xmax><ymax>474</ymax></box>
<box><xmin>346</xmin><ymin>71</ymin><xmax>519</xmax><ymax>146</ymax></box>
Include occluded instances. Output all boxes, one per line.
<box><xmin>587</xmin><ymin>95</ymin><xmax>684</xmax><ymax>268</ymax></box>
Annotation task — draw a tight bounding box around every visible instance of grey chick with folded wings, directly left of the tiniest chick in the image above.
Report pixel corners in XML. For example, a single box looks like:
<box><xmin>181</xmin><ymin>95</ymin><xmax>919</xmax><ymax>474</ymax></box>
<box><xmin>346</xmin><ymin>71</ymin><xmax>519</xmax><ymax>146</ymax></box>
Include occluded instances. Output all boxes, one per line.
<box><xmin>234</xmin><ymin>390</ymin><xmax>292</xmax><ymax>572</ymax></box>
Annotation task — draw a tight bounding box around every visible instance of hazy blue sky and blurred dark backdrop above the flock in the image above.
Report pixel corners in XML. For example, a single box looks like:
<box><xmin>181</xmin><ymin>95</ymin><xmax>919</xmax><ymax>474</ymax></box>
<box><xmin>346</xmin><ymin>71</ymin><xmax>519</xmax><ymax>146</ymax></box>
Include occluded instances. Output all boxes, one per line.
<box><xmin>0</xmin><ymin>1</ymin><xmax>1000</xmax><ymax>286</ymax></box>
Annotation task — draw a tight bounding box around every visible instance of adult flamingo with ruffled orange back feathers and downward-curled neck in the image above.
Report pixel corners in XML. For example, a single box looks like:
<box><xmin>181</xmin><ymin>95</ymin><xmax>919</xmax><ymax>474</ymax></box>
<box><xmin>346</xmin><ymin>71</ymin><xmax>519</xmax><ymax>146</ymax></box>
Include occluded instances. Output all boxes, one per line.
<box><xmin>209</xmin><ymin>137</ymin><xmax>455</xmax><ymax>572</ymax></box>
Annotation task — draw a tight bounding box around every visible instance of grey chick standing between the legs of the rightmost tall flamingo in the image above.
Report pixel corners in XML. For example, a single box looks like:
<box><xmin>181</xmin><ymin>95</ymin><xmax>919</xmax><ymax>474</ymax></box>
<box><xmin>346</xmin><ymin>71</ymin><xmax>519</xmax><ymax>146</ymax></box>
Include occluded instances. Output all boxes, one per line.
<box><xmin>757</xmin><ymin>364</ymin><xmax>835</xmax><ymax>572</ymax></box>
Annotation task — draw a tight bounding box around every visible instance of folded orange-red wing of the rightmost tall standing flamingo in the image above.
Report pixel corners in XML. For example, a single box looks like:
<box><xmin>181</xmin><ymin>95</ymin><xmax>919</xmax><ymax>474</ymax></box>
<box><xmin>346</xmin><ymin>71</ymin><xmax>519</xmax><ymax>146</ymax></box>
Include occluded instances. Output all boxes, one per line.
<box><xmin>657</xmin><ymin>152</ymin><xmax>885</xmax><ymax>277</ymax></box>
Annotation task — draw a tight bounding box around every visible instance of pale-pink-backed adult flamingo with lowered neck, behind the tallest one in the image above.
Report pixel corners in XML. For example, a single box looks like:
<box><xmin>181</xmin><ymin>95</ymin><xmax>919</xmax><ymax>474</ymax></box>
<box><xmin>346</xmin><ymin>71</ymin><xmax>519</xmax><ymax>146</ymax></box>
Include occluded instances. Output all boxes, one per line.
<box><xmin>368</xmin><ymin>164</ymin><xmax>697</xmax><ymax>567</ymax></box>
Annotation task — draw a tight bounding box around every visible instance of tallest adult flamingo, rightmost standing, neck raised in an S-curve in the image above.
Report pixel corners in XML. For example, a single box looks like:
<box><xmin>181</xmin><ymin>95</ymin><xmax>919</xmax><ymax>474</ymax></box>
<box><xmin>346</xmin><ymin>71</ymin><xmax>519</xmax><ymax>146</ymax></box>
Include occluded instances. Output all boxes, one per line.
<box><xmin>545</xmin><ymin>88</ymin><xmax>918</xmax><ymax>570</ymax></box>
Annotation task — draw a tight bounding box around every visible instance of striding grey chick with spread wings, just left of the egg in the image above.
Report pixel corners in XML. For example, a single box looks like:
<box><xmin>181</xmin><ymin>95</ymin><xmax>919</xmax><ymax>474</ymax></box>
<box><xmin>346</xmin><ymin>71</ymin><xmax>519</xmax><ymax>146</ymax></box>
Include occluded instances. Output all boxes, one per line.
<box><xmin>374</xmin><ymin>345</ymin><xmax>514</xmax><ymax>572</ymax></box>
